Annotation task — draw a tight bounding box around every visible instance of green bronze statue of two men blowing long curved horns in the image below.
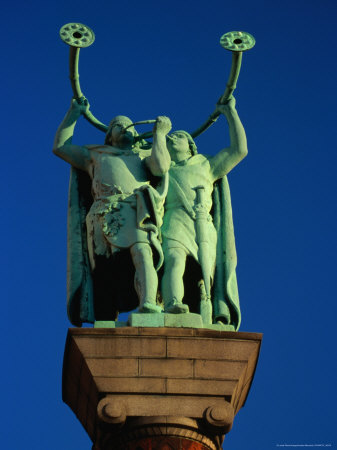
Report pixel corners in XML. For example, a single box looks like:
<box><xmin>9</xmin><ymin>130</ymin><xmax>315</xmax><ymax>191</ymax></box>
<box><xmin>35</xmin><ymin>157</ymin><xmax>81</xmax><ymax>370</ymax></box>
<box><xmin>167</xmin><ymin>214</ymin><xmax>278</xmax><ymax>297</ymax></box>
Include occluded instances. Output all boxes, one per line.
<box><xmin>54</xmin><ymin>23</ymin><xmax>255</xmax><ymax>330</ymax></box>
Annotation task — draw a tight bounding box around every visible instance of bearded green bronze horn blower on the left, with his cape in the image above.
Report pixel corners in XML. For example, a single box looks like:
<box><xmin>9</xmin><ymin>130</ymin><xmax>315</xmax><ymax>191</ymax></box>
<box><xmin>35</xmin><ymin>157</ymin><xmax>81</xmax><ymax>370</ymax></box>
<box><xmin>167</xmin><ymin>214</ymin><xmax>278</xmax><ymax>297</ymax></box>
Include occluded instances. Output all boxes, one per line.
<box><xmin>53</xmin><ymin>97</ymin><xmax>171</xmax><ymax>326</ymax></box>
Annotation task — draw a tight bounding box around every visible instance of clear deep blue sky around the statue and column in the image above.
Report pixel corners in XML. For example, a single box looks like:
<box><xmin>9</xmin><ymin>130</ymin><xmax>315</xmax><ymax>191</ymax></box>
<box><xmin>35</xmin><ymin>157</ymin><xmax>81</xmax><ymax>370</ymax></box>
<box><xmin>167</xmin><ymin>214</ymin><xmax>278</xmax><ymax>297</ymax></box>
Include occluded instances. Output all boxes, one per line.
<box><xmin>0</xmin><ymin>0</ymin><xmax>337</xmax><ymax>450</ymax></box>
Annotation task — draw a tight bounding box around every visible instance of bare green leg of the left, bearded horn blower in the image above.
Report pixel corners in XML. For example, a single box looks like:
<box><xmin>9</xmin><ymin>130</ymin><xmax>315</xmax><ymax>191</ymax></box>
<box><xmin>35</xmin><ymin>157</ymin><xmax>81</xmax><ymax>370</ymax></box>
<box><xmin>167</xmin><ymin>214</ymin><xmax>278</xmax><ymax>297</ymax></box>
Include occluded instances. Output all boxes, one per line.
<box><xmin>130</xmin><ymin>243</ymin><xmax>162</xmax><ymax>313</ymax></box>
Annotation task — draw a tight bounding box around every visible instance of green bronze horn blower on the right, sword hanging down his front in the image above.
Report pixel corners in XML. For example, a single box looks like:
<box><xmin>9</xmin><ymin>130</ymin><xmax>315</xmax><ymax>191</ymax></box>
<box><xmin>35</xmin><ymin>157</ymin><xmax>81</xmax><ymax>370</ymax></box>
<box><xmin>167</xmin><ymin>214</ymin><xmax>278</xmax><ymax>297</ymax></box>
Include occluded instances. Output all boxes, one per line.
<box><xmin>161</xmin><ymin>97</ymin><xmax>247</xmax><ymax>329</ymax></box>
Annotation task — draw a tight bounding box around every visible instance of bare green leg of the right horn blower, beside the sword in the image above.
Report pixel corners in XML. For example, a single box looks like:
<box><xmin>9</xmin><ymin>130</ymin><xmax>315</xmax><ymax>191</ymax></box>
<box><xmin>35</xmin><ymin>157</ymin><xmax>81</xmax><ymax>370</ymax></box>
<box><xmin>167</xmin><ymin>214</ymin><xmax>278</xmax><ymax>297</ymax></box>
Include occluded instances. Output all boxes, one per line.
<box><xmin>162</xmin><ymin>248</ymin><xmax>189</xmax><ymax>314</ymax></box>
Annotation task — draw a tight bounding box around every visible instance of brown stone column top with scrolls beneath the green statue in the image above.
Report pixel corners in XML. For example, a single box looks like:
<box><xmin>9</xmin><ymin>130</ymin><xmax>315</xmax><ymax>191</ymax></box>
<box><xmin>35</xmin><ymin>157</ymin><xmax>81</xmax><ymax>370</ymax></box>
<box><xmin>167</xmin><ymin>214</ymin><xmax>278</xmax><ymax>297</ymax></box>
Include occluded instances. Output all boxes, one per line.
<box><xmin>63</xmin><ymin>327</ymin><xmax>262</xmax><ymax>450</ymax></box>
